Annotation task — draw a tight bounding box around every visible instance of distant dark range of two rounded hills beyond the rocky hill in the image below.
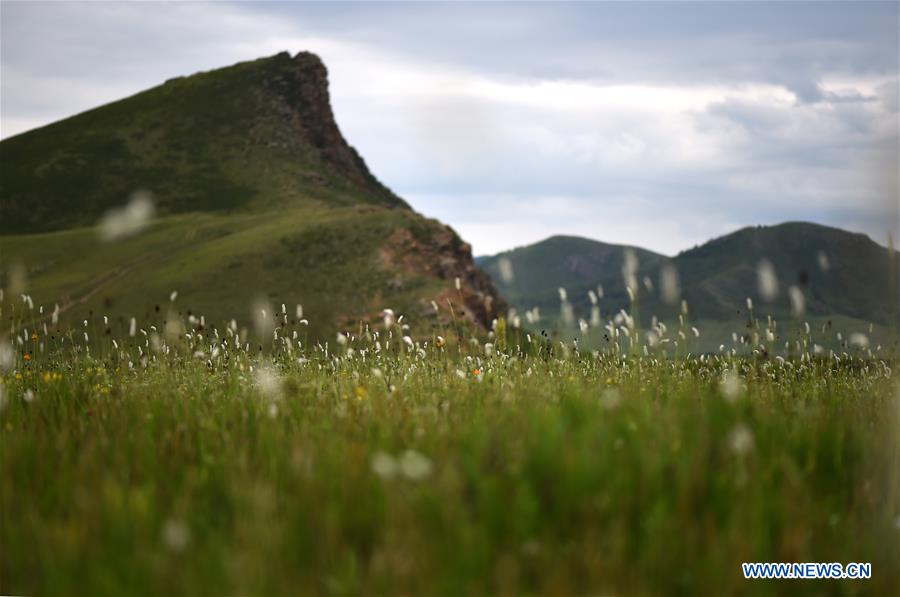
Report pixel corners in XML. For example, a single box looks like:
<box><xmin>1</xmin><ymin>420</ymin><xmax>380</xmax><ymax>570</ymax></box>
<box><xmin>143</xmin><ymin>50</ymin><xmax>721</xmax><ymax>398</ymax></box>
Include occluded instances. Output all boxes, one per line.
<box><xmin>478</xmin><ymin>222</ymin><xmax>900</xmax><ymax>344</ymax></box>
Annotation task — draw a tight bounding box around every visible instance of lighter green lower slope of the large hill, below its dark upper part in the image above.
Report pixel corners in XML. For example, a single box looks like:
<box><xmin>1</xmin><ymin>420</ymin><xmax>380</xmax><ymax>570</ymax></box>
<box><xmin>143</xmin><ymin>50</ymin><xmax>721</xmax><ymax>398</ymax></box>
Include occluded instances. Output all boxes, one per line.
<box><xmin>0</xmin><ymin>206</ymin><xmax>474</xmax><ymax>338</ymax></box>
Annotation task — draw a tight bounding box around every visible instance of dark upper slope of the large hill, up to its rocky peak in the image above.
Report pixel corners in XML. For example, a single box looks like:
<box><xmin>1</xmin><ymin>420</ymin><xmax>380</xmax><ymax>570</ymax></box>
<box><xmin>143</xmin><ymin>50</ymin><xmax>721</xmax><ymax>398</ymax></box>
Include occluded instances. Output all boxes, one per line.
<box><xmin>0</xmin><ymin>53</ymin><xmax>406</xmax><ymax>234</ymax></box>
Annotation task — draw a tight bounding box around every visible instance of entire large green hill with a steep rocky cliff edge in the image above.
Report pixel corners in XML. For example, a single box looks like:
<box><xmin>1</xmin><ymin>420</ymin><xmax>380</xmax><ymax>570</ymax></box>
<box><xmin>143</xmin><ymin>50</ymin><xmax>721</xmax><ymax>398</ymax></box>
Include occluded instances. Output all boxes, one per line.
<box><xmin>0</xmin><ymin>52</ymin><xmax>505</xmax><ymax>335</ymax></box>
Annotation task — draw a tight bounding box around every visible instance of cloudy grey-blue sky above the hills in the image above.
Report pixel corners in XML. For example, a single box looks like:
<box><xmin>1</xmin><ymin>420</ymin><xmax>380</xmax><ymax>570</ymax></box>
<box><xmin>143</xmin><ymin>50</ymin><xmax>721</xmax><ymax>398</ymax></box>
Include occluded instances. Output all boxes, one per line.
<box><xmin>0</xmin><ymin>0</ymin><xmax>900</xmax><ymax>255</ymax></box>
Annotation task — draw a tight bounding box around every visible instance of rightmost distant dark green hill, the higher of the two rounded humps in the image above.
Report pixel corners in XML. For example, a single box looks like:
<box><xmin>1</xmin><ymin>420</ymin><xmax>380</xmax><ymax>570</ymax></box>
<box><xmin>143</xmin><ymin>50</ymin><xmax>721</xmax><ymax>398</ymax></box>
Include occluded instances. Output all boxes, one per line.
<box><xmin>673</xmin><ymin>222</ymin><xmax>900</xmax><ymax>325</ymax></box>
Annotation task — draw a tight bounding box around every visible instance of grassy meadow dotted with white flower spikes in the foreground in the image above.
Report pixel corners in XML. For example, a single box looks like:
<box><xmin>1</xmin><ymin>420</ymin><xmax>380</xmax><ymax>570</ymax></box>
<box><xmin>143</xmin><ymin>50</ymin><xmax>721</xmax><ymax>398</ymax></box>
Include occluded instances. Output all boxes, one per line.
<box><xmin>0</xmin><ymin>301</ymin><xmax>900</xmax><ymax>595</ymax></box>
